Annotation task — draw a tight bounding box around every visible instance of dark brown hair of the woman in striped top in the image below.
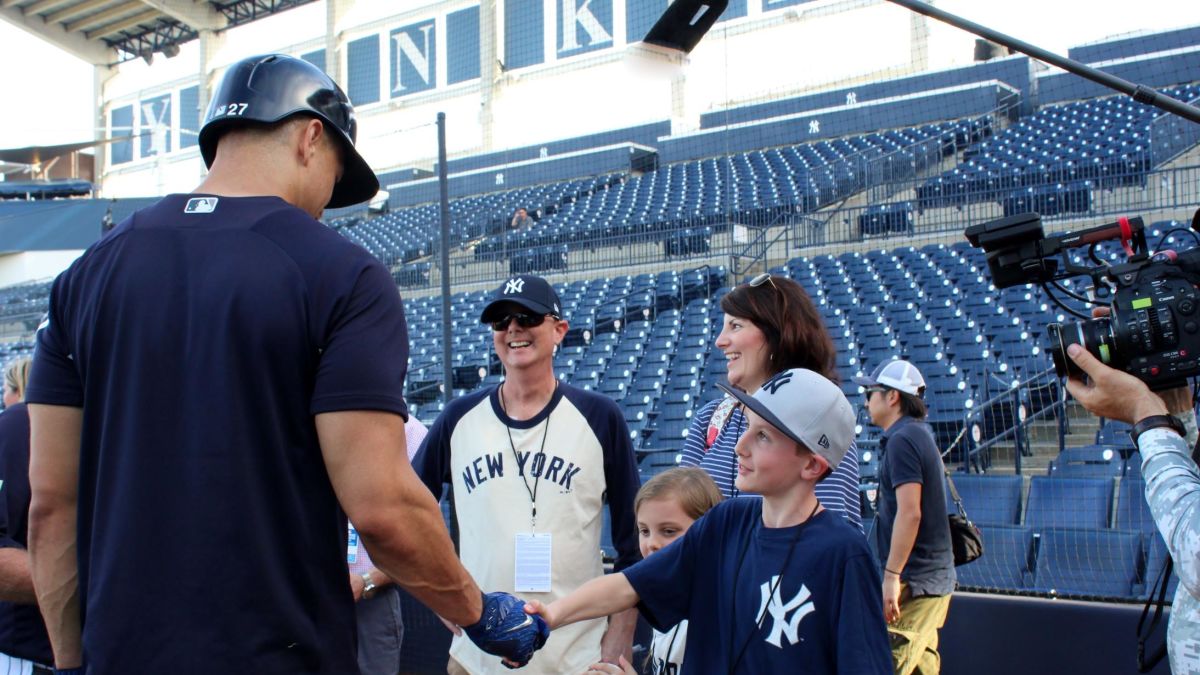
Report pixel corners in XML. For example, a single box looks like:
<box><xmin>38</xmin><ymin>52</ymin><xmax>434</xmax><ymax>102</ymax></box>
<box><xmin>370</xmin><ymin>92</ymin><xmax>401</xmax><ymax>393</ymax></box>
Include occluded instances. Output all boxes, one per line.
<box><xmin>721</xmin><ymin>275</ymin><xmax>841</xmax><ymax>384</ymax></box>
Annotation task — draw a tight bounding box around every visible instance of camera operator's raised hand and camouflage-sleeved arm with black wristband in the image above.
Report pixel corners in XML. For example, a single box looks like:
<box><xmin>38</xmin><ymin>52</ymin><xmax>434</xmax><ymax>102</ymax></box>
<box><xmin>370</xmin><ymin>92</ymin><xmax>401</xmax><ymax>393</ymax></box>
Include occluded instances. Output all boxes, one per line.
<box><xmin>1067</xmin><ymin>345</ymin><xmax>1200</xmax><ymax>674</ymax></box>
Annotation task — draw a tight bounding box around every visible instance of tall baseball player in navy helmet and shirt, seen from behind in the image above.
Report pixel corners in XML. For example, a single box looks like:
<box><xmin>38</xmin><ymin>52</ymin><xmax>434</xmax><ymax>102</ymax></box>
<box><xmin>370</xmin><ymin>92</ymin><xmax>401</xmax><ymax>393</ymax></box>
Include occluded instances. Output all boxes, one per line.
<box><xmin>28</xmin><ymin>54</ymin><xmax>545</xmax><ymax>675</ymax></box>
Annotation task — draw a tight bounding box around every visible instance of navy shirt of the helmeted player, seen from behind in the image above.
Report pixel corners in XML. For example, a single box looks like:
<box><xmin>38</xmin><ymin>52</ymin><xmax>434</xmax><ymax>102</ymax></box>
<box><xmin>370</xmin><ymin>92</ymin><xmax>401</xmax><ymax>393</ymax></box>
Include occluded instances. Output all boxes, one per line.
<box><xmin>28</xmin><ymin>195</ymin><xmax>408</xmax><ymax>675</ymax></box>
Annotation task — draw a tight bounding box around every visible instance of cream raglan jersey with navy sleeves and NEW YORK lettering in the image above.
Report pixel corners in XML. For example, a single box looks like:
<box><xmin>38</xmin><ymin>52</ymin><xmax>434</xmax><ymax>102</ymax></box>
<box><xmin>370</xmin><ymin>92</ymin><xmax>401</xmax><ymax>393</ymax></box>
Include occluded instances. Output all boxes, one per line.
<box><xmin>413</xmin><ymin>384</ymin><xmax>640</xmax><ymax>675</ymax></box>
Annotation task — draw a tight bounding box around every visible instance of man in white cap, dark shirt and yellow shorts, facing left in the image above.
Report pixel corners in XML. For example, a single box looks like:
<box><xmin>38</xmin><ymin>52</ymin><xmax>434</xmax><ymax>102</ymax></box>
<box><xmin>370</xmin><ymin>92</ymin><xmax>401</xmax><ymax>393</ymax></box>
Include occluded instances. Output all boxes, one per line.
<box><xmin>854</xmin><ymin>359</ymin><xmax>955</xmax><ymax>675</ymax></box>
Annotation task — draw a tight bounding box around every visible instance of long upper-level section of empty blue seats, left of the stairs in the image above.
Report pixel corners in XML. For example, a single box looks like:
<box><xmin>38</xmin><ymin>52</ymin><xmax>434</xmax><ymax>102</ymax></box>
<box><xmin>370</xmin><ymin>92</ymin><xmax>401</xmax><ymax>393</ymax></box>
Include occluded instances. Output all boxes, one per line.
<box><xmin>332</xmin><ymin>118</ymin><xmax>991</xmax><ymax>269</ymax></box>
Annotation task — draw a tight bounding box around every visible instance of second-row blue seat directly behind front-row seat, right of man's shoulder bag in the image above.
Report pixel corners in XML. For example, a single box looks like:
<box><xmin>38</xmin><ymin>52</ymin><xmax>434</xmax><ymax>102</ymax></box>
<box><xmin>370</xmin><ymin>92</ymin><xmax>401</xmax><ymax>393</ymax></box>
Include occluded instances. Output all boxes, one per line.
<box><xmin>1025</xmin><ymin>476</ymin><xmax>1112</xmax><ymax>530</ymax></box>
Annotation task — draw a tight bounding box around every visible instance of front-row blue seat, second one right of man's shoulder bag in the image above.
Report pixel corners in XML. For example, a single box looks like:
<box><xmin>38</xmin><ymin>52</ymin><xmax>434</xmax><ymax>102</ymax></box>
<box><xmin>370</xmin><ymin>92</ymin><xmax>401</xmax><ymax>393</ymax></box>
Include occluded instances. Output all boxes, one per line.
<box><xmin>1033</xmin><ymin>527</ymin><xmax>1142</xmax><ymax>598</ymax></box>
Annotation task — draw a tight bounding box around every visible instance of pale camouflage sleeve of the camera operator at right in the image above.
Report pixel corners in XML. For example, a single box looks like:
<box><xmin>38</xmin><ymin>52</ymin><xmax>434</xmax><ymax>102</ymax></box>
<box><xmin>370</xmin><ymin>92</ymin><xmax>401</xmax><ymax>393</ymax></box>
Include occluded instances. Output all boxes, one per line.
<box><xmin>1138</xmin><ymin>413</ymin><xmax>1200</xmax><ymax>597</ymax></box>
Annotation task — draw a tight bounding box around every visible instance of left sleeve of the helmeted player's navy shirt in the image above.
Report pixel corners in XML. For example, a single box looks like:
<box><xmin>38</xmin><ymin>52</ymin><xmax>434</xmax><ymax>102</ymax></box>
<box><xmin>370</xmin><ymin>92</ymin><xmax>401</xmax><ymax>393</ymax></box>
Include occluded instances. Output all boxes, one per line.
<box><xmin>25</xmin><ymin>268</ymin><xmax>83</xmax><ymax>407</ymax></box>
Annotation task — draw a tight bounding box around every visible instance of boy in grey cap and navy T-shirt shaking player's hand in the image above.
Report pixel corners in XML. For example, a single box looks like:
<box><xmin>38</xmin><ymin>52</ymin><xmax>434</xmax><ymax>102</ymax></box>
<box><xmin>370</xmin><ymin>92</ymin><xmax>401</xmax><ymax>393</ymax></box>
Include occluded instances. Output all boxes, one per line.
<box><xmin>526</xmin><ymin>369</ymin><xmax>892</xmax><ymax>675</ymax></box>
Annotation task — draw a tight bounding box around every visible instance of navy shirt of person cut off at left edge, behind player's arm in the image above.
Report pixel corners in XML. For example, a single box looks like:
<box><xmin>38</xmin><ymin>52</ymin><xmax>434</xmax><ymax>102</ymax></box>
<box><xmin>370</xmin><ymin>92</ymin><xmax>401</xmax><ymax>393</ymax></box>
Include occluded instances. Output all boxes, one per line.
<box><xmin>0</xmin><ymin>404</ymin><xmax>54</xmax><ymax>665</ymax></box>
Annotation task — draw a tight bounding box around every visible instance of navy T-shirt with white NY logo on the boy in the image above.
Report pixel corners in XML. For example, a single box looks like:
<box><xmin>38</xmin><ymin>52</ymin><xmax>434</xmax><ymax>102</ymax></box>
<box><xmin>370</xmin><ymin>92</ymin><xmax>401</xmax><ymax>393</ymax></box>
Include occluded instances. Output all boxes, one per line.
<box><xmin>624</xmin><ymin>500</ymin><xmax>893</xmax><ymax>675</ymax></box>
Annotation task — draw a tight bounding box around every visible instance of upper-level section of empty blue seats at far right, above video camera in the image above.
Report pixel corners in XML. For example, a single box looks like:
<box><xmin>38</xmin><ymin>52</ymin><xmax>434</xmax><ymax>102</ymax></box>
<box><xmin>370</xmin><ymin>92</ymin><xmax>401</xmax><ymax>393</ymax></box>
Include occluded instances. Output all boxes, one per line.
<box><xmin>917</xmin><ymin>84</ymin><xmax>1200</xmax><ymax>211</ymax></box>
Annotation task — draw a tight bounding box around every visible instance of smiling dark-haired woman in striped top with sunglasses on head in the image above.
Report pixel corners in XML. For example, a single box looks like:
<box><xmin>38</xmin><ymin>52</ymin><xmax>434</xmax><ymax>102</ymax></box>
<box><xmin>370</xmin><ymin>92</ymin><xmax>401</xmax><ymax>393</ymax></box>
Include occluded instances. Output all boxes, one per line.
<box><xmin>679</xmin><ymin>274</ymin><xmax>863</xmax><ymax>530</ymax></box>
